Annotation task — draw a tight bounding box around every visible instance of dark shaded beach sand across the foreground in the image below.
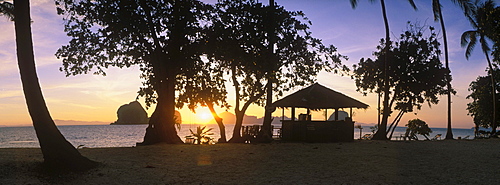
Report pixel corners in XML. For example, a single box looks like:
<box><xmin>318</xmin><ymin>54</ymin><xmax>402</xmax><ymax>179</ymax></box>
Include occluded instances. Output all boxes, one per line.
<box><xmin>0</xmin><ymin>139</ymin><xmax>500</xmax><ymax>185</ymax></box>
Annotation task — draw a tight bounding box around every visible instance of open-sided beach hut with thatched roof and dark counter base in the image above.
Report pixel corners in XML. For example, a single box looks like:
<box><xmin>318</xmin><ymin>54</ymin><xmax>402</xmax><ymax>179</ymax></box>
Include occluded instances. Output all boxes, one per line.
<box><xmin>272</xmin><ymin>83</ymin><xmax>368</xmax><ymax>142</ymax></box>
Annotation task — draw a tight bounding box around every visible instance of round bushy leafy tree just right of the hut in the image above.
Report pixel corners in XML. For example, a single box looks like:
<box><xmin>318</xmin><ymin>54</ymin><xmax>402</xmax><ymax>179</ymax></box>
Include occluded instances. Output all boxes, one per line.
<box><xmin>353</xmin><ymin>24</ymin><xmax>449</xmax><ymax>135</ymax></box>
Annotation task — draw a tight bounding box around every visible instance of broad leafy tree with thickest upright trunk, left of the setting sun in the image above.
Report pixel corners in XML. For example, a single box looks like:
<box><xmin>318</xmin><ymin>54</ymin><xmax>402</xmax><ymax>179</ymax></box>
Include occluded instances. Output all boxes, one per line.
<box><xmin>56</xmin><ymin>0</ymin><xmax>212</xmax><ymax>144</ymax></box>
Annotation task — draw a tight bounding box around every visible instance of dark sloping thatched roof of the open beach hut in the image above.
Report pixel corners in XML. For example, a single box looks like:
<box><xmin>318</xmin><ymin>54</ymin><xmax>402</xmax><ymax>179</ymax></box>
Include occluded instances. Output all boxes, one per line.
<box><xmin>273</xmin><ymin>83</ymin><xmax>368</xmax><ymax>109</ymax></box>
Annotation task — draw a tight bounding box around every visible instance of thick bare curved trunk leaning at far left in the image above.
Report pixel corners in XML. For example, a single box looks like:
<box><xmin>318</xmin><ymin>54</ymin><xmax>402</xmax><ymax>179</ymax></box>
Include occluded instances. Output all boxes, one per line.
<box><xmin>14</xmin><ymin>0</ymin><xmax>97</xmax><ymax>171</ymax></box>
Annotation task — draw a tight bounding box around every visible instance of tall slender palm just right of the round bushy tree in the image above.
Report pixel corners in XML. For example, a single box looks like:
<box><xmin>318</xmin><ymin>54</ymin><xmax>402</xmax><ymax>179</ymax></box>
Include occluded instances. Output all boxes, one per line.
<box><xmin>432</xmin><ymin>0</ymin><xmax>472</xmax><ymax>139</ymax></box>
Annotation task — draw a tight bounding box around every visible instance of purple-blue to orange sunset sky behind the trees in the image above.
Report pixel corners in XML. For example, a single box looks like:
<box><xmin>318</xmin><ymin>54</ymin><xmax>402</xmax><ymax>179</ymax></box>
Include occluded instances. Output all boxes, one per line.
<box><xmin>0</xmin><ymin>0</ymin><xmax>500</xmax><ymax>128</ymax></box>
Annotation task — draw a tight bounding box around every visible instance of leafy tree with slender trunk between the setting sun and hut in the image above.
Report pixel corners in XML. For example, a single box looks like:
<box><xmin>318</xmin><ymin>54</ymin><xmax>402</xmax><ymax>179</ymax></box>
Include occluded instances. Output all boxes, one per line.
<box><xmin>208</xmin><ymin>0</ymin><xmax>347</xmax><ymax>142</ymax></box>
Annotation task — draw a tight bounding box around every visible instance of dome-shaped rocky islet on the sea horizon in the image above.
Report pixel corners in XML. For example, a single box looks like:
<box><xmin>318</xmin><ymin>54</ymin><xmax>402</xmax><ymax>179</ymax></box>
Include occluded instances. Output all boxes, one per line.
<box><xmin>111</xmin><ymin>101</ymin><xmax>149</xmax><ymax>125</ymax></box>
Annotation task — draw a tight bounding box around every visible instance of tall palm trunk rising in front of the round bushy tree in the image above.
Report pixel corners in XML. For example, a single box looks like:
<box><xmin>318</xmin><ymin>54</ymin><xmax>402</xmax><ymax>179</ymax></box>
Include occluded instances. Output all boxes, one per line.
<box><xmin>350</xmin><ymin>0</ymin><xmax>417</xmax><ymax>140</ymax></box>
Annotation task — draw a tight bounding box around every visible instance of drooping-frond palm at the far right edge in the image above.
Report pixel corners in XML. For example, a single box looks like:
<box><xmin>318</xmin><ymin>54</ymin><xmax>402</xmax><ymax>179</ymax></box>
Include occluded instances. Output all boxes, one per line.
<box><xmin>460</xmin><ymin>0</ymin><xmax>497</xmax><ymax>134</ymax></box>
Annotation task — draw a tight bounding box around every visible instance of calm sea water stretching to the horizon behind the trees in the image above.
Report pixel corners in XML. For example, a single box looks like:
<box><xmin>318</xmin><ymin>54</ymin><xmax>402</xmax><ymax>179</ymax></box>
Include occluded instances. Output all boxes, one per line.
<box><xmin>0</xmin><ymin>124</ymin><xmax>474</xmax><ymax>148</ymax></box>
